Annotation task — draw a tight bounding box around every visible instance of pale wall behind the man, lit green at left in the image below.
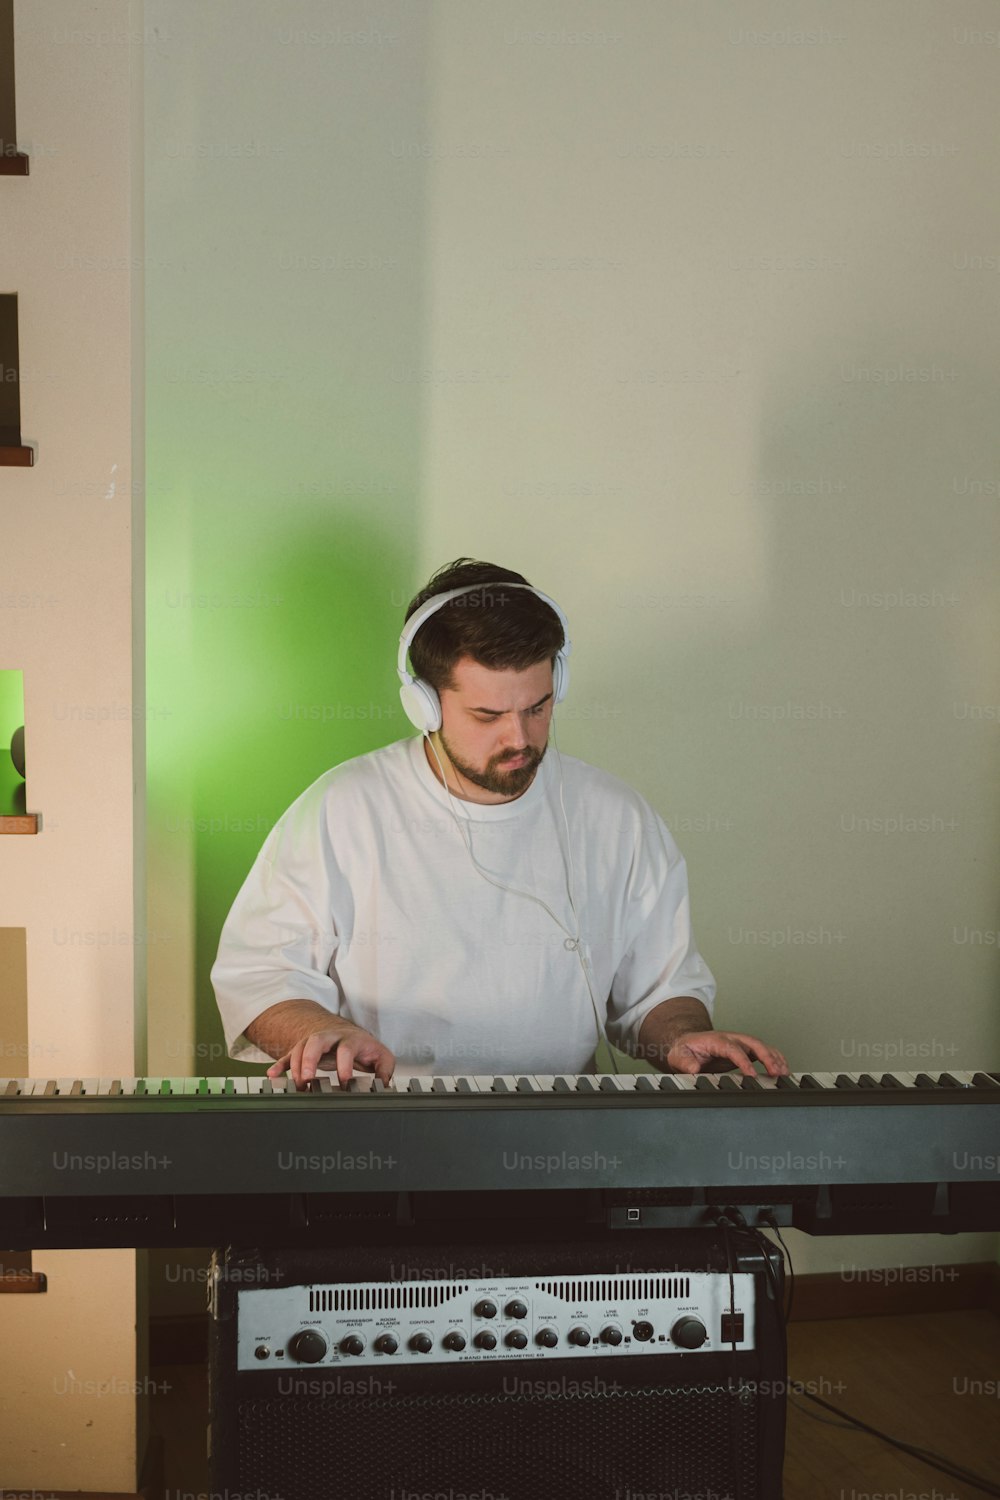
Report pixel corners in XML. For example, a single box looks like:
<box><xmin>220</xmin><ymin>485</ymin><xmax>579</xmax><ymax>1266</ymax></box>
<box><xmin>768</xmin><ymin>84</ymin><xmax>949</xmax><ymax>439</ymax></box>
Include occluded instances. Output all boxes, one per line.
<box><xmin>147</xmin><ymin>0</ymin><xmax>1000</xmax><ymax>1302</ymax></box>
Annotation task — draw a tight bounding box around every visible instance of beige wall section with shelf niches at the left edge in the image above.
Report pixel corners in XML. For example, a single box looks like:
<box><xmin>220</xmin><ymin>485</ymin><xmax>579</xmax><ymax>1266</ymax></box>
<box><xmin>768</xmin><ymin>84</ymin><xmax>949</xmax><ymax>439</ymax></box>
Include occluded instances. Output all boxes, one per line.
<box><xmin>0</xmin><ymin>0</ymin><xmax>147</xmax><ymax>1493</ymax></box>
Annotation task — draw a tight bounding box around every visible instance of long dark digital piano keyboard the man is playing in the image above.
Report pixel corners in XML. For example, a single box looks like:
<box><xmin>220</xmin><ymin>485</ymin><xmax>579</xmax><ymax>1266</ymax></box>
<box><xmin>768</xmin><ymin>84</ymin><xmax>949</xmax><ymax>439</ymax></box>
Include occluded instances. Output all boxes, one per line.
<box><xmin>0</xmin><ymin>1071</ymin><xmax>1000</xmax><ymax>1250</ymax></box>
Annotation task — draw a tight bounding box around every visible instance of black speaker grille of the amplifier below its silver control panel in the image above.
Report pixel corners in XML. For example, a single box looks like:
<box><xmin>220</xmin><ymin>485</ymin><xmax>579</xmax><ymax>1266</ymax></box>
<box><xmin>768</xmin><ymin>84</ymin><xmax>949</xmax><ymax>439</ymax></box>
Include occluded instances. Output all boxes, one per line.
<box><xmin>235</xmin><ymin>1371</ymin><xmax>758</xmax><ymax>1500</ymax></box>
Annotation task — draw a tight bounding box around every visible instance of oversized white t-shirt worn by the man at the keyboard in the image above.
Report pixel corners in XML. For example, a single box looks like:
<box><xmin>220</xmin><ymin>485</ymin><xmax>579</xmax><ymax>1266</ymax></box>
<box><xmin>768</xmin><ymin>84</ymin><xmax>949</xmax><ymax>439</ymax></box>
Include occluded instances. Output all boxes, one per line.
<box><xmin>211</xmin><ymin>737</ymin><xmax>715</xmax><ymax>1076</ymax></box>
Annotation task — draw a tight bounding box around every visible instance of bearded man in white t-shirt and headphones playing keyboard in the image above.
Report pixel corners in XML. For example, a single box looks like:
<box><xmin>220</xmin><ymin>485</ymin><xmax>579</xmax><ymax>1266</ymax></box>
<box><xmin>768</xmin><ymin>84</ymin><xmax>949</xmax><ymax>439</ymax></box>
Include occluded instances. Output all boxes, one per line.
<box><xmin>211</xmin><ymin>558</ymin><xmax>787</xmax><ymax>1088</ymax></box>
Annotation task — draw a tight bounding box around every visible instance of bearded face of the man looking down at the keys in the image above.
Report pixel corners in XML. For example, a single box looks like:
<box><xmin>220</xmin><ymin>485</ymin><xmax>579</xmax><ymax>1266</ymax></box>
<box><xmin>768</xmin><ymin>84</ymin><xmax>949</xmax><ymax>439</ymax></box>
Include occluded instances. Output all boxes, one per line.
<box><xmin>438</xmin><ymin>657</ymin><xmax>552</xmax><ymax>803</ymax></box>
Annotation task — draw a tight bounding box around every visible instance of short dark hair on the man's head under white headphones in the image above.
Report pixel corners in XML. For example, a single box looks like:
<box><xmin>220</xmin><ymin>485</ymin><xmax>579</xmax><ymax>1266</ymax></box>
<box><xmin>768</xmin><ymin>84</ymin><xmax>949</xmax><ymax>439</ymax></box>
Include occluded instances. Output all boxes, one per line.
<box><xmin>406</xmin><ymin>558</ymin><xmax>565</xmax><ymax>693</ymax></box>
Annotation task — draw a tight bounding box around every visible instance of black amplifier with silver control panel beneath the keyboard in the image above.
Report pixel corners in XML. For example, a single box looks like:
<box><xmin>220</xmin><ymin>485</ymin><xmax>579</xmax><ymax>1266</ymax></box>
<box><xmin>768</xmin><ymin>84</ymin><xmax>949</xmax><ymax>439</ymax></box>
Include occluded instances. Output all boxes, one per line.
<box><xmin>210</xmin><ymin>1224</ymin><xmax>786</xmax><ymax>1500</ymax></box>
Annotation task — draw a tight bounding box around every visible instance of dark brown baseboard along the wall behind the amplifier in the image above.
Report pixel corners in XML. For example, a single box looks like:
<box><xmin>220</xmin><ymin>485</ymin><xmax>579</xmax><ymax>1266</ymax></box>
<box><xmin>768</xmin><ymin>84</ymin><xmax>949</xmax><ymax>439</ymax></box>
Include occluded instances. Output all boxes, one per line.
<box><xmin>148</xmin><ymin>1260</ymin><xmax>1000</xmax><ymax>1368</ymax></box>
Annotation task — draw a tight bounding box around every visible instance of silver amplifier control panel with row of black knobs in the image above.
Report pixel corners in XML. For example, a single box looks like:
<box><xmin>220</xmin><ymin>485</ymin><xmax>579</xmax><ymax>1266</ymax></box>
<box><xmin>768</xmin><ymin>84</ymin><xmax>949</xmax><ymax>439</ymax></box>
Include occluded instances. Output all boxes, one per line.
<box><xmin>237</xmin><ymin>1271</ymin><xmax>754</xmax><ymax>1371</ymax></box>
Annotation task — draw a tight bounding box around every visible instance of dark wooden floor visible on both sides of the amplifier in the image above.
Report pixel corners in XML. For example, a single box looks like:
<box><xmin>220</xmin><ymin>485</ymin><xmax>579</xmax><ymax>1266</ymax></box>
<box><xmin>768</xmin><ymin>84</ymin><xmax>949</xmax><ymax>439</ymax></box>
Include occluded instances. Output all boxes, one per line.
<box><xmin>153</xmin><ymin>1310</ymin><xmax>1000</xmax><ymax>1500</ymax></box>
